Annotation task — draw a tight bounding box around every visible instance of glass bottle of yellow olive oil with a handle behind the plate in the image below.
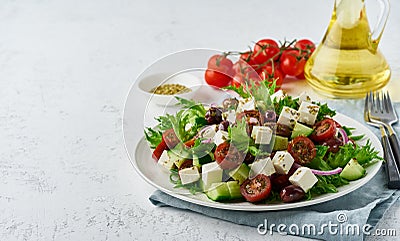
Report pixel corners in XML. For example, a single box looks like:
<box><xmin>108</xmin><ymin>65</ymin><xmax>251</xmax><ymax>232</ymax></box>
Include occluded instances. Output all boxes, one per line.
<box><xmin>304</xmin><ymin>0</ymin><xmax>391</xmax><ymax>98</ymax></box>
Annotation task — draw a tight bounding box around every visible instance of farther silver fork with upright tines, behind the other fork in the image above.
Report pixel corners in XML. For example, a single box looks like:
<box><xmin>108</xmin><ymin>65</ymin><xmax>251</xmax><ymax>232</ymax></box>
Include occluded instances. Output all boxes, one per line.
<box><xmin>369</xmin><ymin>92</ymin><xmax>400</xmax><ymax>167</ymax></box>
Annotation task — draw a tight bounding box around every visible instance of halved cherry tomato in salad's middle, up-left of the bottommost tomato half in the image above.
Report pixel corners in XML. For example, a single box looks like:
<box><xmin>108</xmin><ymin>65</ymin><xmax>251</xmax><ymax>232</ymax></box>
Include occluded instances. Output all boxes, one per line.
<box><xmin>214</xmin><ymin>142</ymin><xmax>243</xmax><ymax>170</ymax></box>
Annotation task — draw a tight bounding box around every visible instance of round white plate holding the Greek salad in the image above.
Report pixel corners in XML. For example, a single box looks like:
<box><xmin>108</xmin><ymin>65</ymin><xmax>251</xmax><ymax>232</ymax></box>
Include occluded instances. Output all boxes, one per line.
<box><xmin>125</xmin><ymin>114</ymin><xmax>383</xmax><ymax>211</ymax></box>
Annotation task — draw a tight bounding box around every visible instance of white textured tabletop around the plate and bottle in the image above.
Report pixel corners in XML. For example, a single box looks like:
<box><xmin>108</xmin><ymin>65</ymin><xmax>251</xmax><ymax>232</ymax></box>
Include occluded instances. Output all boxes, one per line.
<box><xmin>0</xmin><ymin>0</ymin><xmax>400</xmax><ymax>240</ymax></box>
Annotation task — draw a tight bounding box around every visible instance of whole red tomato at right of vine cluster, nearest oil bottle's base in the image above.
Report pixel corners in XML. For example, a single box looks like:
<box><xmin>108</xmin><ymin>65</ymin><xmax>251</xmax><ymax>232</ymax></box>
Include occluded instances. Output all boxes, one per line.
<box><xmin>280</xmin><ymin>50</ymin><xmax>306</xmax><ymax>76</ymax></box>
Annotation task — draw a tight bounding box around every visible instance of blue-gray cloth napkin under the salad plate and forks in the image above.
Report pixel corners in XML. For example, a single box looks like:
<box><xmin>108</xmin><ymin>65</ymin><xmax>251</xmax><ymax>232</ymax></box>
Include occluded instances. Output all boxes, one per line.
<box><xmin>149</xmin><ymin>100</ymin><xmax>400</xmax><ymax>240</ymax></box>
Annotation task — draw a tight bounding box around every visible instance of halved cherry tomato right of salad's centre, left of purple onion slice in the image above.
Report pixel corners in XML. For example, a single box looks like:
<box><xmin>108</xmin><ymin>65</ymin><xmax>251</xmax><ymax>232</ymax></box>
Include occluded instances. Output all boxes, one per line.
<box><xmin>288</xmin><ymin>136</ymin><xmax>317</xmax><ymax>165</ymax></box>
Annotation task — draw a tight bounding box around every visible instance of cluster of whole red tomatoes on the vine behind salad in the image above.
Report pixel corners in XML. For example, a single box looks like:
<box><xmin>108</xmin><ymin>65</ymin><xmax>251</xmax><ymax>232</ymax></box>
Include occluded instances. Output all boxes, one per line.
<box><xmin>205</xmin><ymin>39</ymin><xmax>315</xmax><ymax>88</ymax></box>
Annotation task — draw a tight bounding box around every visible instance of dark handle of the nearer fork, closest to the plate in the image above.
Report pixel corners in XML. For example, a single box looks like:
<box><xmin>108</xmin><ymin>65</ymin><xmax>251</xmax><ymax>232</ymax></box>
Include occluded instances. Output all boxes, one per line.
<box><xmin>382</xmin><ymin>134</ymin><xmax>400</xmax><ymax>189</ymax></box>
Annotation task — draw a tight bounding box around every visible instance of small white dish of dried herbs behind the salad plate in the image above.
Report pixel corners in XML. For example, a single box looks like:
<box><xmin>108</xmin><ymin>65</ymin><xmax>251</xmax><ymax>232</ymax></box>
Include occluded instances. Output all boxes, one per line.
<box><xmin>137</xmin><ymin>71</ymin><xmax>202</xmax><ymax>106</ymax></box>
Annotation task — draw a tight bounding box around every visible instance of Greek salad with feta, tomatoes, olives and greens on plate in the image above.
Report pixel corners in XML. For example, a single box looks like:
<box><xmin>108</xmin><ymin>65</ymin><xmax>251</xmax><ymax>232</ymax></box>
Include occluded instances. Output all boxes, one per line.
<box><xmin>145</xmin><ymin>81</ymin><xmax>382</xmax><ymax>203</ymax></box>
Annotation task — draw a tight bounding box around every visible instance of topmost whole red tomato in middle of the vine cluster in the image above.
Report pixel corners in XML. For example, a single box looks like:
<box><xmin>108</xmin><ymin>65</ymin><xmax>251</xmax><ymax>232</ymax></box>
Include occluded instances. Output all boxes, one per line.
<box><xmin>253</xmin><ymin>39</ymin><xmax>280</xmax><ymax>64</ymax></box>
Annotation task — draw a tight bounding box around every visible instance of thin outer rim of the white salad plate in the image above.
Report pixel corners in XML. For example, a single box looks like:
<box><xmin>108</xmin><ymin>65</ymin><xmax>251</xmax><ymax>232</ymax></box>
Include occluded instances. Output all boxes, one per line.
<box><xmin>128</xmin><ymin>113</ymin><xmax>383</xmax><ymax>211</ymax></box>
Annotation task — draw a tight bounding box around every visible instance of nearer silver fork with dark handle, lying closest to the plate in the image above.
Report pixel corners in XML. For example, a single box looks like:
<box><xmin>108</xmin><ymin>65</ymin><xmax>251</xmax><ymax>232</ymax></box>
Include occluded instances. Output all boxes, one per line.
<box><xmin>364</xmin><ymin>93</ymin><xmax>400</xmax><ymax>189</ymax></box>
